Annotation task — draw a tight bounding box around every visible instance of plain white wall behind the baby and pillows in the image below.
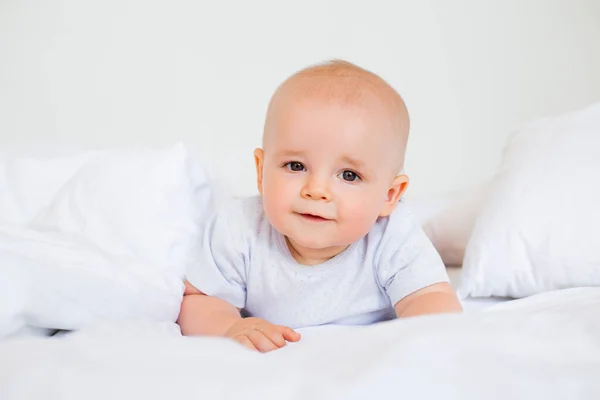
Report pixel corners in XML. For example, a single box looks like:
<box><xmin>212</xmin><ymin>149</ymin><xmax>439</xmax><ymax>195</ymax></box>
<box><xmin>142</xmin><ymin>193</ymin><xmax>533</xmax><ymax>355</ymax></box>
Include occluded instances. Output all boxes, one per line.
<box><xmin>0</xmin><ymin>0</ymin><xmax>600</xmax><ymax>194</ymax></box>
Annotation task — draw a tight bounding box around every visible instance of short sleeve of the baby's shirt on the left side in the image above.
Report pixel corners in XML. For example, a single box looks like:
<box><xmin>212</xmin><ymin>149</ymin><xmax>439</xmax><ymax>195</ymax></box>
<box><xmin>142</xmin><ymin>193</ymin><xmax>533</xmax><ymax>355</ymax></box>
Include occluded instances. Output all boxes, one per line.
<box><xmin>186</xmin><ymin>205</ymin><xmax>248</xmax><ymax>308</ymax></box>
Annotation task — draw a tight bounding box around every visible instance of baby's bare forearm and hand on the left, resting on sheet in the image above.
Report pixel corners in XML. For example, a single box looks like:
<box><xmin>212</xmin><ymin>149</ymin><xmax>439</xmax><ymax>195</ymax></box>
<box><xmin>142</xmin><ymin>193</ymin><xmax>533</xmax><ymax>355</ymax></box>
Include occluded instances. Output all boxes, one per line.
<box><xmin>177</xmin><ymin>281</ymin><xmax>300</xmax><ymax>352</ymax></box>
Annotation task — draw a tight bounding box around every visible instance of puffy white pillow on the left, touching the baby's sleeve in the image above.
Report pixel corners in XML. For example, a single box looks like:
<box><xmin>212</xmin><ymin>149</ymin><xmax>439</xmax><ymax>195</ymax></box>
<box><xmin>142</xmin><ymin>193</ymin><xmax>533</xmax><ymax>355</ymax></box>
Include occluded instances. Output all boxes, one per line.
<box><xmin>30</xmin><ymin>144</ymin><xmax>212</xmax><ymax>276</ymax></box>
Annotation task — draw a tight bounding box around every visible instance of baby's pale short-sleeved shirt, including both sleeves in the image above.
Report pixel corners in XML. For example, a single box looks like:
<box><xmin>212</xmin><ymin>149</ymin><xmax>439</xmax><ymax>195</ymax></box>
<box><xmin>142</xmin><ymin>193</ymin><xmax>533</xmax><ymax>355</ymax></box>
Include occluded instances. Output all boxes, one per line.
<box><xmin>187</xmin><ymin>197</ymin><xmax>448</xmax><ymax>328</ymax></box>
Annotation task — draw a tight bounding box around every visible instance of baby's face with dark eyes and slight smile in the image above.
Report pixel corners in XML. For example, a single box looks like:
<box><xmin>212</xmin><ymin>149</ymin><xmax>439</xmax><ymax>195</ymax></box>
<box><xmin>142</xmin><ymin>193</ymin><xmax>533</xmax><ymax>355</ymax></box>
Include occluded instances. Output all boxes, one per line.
<box><xmin>257</xmin><ymin>97</ymin><xmax>404</xmax><ymax>253</ymax></box>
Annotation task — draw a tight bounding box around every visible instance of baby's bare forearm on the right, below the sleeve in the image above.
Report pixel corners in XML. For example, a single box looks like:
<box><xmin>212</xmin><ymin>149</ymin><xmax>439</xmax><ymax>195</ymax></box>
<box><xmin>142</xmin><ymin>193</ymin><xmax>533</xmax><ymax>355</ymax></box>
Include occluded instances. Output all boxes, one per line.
<box><xmin>394</xmin><ymin>282</ymin><xmax>462</xmax><ymax>317</ymax></box>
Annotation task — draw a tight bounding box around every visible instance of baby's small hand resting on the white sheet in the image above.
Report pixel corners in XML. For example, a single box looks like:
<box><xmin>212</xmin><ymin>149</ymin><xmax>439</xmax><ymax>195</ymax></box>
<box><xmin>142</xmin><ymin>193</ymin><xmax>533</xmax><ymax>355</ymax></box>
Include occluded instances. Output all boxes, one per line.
<box><xmin>225</xmin><ymin>318</ymin><xmax>300</xmax><ymax>353</ymax></box>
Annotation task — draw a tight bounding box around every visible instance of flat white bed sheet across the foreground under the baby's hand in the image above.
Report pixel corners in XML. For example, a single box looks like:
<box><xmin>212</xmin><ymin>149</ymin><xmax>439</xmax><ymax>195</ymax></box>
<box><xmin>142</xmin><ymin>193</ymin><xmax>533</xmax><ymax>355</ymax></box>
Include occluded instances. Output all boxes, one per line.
<box><xmin>0</xmin><ymin>288</ymin><xmax>600</xmax><ymax>400</ymax></box>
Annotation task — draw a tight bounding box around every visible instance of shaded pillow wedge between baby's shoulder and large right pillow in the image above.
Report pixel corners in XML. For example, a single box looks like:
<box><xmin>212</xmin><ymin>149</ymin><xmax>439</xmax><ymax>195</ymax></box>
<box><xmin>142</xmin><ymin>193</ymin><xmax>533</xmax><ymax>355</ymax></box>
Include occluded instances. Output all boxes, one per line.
<box><xmin>409</xmin><ymin>184</ymin><xmax>488</xmax><ymax>266</ymax></box>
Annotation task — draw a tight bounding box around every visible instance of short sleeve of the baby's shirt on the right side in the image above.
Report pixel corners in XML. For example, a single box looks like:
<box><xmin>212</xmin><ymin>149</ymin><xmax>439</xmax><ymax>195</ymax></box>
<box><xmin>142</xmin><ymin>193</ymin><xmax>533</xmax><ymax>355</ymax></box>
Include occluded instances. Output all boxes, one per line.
<box><xmin>376</xmin><ymin>203</ymin><xmax>449</xmax><ymax>306</ymax></box>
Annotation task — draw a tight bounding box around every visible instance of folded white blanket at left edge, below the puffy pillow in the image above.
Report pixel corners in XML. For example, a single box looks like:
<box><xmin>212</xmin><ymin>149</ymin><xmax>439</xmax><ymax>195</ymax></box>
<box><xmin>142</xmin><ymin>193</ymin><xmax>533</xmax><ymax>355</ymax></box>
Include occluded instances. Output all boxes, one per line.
<box><xmin>0</xmin><ymin>222</ymin><xmax>183</xmax><ymax>338</ymax></box>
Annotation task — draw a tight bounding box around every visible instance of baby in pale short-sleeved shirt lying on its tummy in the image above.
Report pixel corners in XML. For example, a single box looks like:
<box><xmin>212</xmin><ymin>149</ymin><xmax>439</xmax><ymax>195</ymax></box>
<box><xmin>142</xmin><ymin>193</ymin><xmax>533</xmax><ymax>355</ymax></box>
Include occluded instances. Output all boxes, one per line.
<box><xmin>178</xmin><ymin>61</ymin><xmax>461</xmax><ymax>352</ymax></box>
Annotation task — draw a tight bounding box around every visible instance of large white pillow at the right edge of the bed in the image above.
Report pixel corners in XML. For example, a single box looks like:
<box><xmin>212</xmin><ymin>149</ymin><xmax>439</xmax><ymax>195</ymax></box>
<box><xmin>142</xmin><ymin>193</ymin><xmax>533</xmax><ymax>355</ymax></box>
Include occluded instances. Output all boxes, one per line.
<box><xmin>459</xmin><ymin>104</ymin><xmax>600</xmax><ymax>297</ymax></box>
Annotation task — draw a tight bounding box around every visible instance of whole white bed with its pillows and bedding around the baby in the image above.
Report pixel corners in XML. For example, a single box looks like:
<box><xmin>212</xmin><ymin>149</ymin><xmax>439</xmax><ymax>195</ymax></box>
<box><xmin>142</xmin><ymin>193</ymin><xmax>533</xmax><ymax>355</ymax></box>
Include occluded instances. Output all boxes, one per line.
<box><xmin>0</xmin><ymin>105</ymin><xmax>600</xmax><ymax>400</ymax></box>
